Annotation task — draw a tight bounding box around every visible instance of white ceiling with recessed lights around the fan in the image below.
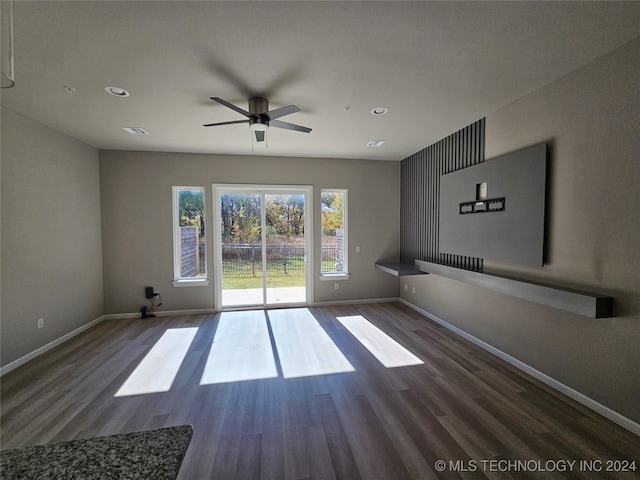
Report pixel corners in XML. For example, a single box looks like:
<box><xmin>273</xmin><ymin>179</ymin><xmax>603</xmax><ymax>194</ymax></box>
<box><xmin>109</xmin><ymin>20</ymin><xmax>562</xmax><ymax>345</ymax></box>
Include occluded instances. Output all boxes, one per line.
<box><xmin>2</xmin><ymin>0</ymin><xmax>640</xmax><ymax>160</ymax></box>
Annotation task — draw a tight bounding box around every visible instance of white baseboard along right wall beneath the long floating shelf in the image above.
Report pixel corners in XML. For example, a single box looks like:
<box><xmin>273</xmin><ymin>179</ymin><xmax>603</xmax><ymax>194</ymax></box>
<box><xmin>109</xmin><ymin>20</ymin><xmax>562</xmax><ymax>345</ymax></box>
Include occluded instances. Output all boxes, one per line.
<box><xmin>399</xmin><ymin>298</ymin><xmax>640</xmax><ymax>436</ymax></box>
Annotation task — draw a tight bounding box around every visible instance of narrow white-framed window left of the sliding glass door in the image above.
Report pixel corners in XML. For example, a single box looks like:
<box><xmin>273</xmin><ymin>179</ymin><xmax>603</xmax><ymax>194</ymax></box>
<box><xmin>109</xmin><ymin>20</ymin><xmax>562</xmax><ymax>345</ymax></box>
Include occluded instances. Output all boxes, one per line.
<box><xmin>173</xmin><ymin>187</ymin><xmax>208</xmax><ymax>286</ymax></box>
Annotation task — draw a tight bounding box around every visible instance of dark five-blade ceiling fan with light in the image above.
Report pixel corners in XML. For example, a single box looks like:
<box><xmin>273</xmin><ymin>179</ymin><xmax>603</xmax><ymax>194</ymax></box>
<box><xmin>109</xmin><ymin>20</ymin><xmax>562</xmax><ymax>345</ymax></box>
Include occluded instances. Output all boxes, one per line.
<box><xmin>203</xmin><ymin>97</ymin><xmax>311</xmax><ymax>142</ymax></box>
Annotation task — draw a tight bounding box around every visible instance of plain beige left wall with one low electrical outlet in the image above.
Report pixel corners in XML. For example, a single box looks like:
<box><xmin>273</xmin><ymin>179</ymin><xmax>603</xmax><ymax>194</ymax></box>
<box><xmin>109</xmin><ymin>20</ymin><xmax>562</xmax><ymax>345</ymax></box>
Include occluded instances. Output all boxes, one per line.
<box><xmin>0</xmin><ymin>108</ymin><xmax>104</xmax><ymax>366</ymax></box>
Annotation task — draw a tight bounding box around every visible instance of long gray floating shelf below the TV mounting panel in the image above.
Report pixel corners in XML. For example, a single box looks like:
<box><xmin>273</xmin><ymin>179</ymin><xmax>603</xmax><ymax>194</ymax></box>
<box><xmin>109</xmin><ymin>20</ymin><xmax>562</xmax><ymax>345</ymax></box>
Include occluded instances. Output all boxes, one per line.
<box><xmin>415</xmin><ymin>260</ymin><xmax>613</xmax><ymax>318</ymax></box>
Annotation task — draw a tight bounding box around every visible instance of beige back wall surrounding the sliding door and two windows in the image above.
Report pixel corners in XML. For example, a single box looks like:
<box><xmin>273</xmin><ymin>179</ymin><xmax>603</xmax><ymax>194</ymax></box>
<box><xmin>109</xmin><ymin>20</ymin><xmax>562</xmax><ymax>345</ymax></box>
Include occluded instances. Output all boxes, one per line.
<box><xmin>100</xmin><ymin>151</ymin><xmax>400</xmax><ymax>314</ymax></box>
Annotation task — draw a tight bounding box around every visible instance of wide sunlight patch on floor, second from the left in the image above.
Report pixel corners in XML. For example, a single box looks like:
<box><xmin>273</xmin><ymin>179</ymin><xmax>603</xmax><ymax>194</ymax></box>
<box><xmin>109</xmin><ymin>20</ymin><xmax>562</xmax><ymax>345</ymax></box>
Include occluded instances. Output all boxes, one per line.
<box><xmin>200</xmin><ymin>310</ymin><xmax>278</xmax><ymax>385</ymax></box>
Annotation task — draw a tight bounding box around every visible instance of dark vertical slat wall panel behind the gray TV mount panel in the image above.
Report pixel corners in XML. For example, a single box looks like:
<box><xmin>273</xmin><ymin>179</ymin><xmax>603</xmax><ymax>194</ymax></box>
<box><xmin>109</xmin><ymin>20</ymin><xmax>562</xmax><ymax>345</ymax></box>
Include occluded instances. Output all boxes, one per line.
<box><xmin>400</xmin><ymin>119</ymin><xmax>485</xmax><ymax>271</ymax></box>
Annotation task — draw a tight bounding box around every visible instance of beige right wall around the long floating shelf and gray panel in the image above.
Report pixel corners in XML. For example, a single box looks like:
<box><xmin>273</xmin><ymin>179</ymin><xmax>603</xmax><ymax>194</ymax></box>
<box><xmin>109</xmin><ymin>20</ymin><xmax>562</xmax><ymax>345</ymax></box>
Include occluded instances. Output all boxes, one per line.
<box><xmin>401</xmin><ymin>40</ymin><xmax>640</xmax><ymax>422</ymax></box>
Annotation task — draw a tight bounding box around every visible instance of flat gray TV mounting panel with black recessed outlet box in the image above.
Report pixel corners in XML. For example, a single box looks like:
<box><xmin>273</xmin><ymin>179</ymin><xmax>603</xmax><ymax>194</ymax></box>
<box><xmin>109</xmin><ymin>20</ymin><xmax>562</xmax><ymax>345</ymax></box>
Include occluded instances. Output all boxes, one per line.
<box><xmin>439</xmin><ymin>143</ymin><xmax>547</xmax><ymax>267</ymax></box>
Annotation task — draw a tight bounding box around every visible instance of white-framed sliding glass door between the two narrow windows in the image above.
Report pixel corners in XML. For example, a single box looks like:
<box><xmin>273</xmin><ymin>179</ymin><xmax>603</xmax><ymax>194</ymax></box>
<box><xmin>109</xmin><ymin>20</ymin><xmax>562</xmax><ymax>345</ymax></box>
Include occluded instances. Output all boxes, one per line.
<box><xmin>213</xmin><ymin>185</ymin><xmax>312</xmax><ymax>309</ymax></box>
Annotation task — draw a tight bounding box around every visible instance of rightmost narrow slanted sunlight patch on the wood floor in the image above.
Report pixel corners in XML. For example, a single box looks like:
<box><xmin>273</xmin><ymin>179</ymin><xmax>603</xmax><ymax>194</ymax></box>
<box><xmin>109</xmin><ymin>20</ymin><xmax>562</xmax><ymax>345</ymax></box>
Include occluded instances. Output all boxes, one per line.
<box><xmin>336</xmin><ymin>315</ymin><xmax>424</xmax><ymax>368</ymax></box>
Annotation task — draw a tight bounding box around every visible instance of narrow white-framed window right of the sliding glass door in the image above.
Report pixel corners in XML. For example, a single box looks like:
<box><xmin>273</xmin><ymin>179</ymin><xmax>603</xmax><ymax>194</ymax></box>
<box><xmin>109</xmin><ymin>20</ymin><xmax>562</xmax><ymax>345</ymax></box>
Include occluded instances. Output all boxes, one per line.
<box><xmin>320</xmin><ymin>190</ymin><xmax>348</xmax><ymax>276</ymax></box>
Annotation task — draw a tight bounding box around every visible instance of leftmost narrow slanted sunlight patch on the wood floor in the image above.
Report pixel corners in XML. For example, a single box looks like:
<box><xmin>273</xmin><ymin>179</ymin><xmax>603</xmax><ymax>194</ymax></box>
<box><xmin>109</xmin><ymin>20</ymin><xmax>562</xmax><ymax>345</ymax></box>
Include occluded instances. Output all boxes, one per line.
<box><xmin>115</xmin><ymin>328</ymin><xmax>198</xmax><ymax>397</ymax></box>
